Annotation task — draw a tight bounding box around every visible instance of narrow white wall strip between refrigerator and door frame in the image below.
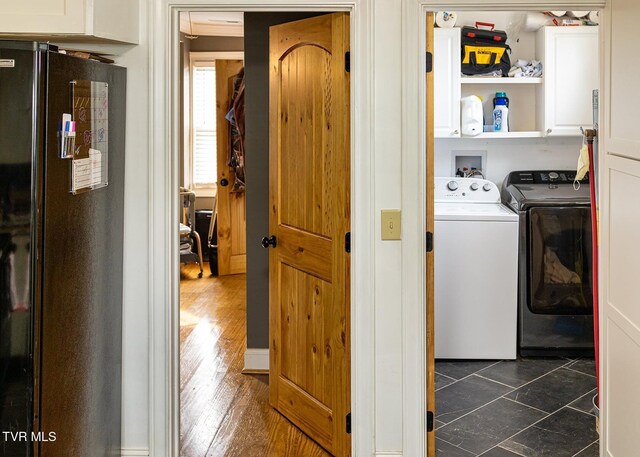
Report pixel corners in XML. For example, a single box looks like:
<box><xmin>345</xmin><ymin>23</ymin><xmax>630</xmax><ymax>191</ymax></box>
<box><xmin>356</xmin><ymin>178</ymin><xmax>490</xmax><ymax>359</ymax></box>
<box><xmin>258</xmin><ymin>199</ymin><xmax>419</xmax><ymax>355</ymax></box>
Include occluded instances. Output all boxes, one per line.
<box><xmin>115</xmin><ymin>12</ymin><xmax>153</xmax><ymax>455</ymax></box>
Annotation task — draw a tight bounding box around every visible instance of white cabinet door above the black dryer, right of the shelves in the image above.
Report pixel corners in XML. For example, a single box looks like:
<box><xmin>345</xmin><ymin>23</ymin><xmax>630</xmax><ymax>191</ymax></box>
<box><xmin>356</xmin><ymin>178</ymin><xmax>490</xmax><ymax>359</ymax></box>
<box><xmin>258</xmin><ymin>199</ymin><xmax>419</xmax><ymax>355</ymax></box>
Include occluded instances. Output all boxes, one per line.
<box><xmin>538</xmin><ymin>27</ymin><xmax>600</xmax><ymax>136</ymax></box>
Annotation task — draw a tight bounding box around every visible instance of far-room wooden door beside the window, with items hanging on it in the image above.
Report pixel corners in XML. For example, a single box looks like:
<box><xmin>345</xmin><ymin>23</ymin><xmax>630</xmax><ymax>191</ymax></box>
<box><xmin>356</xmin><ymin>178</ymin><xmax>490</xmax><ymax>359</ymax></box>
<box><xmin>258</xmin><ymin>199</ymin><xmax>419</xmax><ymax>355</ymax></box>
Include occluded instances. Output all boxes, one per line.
<box><xmin>216</xmin><ymin>60</ymin><xmax>247</xmax><ymax>276</ymax></box>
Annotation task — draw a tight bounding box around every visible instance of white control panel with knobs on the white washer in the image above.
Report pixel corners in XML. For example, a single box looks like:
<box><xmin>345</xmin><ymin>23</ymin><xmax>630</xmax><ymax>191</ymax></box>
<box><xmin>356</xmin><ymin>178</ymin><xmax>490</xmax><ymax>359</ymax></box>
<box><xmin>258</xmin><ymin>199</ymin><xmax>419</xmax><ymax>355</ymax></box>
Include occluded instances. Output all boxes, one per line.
<box><xmin>435</xmin><ymin>177</ymin><xmax>500</xmax><ymax>203</ymax></box>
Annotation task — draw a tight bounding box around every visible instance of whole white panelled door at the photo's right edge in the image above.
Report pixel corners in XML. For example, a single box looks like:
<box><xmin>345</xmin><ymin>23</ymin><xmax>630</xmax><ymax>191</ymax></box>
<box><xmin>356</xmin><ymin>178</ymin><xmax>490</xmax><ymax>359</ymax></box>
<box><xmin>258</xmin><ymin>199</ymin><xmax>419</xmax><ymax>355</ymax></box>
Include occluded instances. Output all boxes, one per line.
<box><xmin>604</xmin><ymin>0</ymin><xmax>640</xmax><ymax>457</ymax></box>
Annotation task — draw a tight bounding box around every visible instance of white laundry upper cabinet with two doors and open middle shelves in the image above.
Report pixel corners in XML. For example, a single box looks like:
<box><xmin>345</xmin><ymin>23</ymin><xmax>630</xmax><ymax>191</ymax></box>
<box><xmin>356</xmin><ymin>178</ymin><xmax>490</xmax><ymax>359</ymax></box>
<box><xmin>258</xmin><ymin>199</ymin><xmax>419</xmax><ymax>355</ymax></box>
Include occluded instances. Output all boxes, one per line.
<box><xmin>433</xmin><ymin>26</ymin><xmax>600</xmax><ymax>138</ymax></box>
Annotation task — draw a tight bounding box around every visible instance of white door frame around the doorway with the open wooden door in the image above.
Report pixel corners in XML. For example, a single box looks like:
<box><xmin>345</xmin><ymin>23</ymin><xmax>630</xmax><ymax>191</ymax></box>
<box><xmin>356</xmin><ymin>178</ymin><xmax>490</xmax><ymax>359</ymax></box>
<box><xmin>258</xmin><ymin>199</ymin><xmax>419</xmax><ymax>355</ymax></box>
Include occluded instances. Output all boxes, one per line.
<box><xmin>149</xmin><ymin>0</ymin><xmax>375</xmax><ymax>456</ymax></box>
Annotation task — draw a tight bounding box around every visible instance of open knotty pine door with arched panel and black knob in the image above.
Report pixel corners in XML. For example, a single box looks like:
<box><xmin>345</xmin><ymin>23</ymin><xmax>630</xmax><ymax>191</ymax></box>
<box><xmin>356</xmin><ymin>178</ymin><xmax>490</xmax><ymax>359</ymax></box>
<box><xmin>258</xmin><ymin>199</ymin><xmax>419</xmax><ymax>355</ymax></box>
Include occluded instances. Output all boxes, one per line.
<box><xmin>269</xmin><ymin>13</ymin><xmax>351</xmax><ymax>456</ymax></box>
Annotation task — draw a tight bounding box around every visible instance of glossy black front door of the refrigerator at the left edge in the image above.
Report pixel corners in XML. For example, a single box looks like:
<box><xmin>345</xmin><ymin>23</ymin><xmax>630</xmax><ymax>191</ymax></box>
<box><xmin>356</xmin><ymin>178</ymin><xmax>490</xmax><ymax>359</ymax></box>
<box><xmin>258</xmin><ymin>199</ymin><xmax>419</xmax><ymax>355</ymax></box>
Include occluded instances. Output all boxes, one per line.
<box><xmin>0</xmin><ymin>41</ymin><xmax>42</xmax><ymax>457</ymax></box>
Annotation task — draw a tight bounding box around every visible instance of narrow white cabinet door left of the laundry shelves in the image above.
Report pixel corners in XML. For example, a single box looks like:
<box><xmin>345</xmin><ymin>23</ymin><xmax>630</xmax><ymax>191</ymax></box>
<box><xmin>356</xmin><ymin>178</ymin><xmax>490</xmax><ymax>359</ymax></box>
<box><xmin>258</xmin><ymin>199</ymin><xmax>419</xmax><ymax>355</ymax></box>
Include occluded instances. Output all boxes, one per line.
<box><xmin>433</xmin><ymin>28</ymin><xmax>460</xmax><ymax>138</ymax></box>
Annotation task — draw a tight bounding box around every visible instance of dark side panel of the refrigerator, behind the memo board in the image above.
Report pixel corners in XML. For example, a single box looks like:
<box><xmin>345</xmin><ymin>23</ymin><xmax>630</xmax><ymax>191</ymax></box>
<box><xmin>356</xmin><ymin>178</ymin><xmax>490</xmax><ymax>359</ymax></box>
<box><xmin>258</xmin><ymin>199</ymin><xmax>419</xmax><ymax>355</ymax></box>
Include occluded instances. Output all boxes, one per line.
<box><xmin>40</xmin><ymin>53</ymin><xmax>126</xmax><ymax>457</ymax></box>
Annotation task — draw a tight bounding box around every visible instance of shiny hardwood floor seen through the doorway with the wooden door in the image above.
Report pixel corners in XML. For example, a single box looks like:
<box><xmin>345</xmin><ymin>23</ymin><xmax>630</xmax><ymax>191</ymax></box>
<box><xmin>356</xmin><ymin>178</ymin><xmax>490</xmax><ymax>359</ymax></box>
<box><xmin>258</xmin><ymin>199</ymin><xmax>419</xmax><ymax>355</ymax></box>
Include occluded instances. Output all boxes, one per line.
<box><xmin>180</xmin><ymin>265</ymin><xmax>329</xmax><ymax>457</ymax></box>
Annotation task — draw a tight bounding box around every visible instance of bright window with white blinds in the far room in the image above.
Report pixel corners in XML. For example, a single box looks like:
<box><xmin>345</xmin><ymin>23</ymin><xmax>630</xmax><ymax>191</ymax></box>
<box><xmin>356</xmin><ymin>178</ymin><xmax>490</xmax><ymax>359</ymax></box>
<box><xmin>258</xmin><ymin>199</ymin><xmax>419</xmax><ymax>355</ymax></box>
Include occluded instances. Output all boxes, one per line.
<box><xmin>190</xmin><ymin>61</ymin><xmax>217</xmax><ymax>189</ymax></box>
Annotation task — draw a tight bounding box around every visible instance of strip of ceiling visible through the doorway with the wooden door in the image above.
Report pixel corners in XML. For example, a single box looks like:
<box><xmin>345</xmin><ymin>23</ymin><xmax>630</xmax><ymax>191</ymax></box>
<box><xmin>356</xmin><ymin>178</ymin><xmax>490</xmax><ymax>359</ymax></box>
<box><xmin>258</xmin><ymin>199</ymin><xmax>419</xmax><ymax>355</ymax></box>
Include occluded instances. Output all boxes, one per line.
<box><xmin>180</xmin><ymin>11</ymin><xmax>244</xmax><ymax>37</ymax></box>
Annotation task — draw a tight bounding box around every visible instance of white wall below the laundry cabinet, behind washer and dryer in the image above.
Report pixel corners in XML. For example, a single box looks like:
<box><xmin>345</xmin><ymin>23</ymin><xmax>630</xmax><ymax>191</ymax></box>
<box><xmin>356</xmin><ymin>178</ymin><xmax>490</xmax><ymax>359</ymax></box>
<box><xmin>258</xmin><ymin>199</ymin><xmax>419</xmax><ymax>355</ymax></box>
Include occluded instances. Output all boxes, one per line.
<box><xmin>435</xmin><ymin>137</ymin><xmax>582</xmax><ymax>186</ymax></box>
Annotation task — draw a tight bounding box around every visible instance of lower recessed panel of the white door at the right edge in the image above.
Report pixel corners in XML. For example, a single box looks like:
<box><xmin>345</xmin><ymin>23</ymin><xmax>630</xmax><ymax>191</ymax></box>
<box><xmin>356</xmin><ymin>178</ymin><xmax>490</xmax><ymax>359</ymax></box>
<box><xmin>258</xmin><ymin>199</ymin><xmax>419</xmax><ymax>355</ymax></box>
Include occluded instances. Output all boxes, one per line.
<box><xmin>600</xmin><ymin>157</ymin><xmax>640</xmax><ymax>457</ymax></box>
